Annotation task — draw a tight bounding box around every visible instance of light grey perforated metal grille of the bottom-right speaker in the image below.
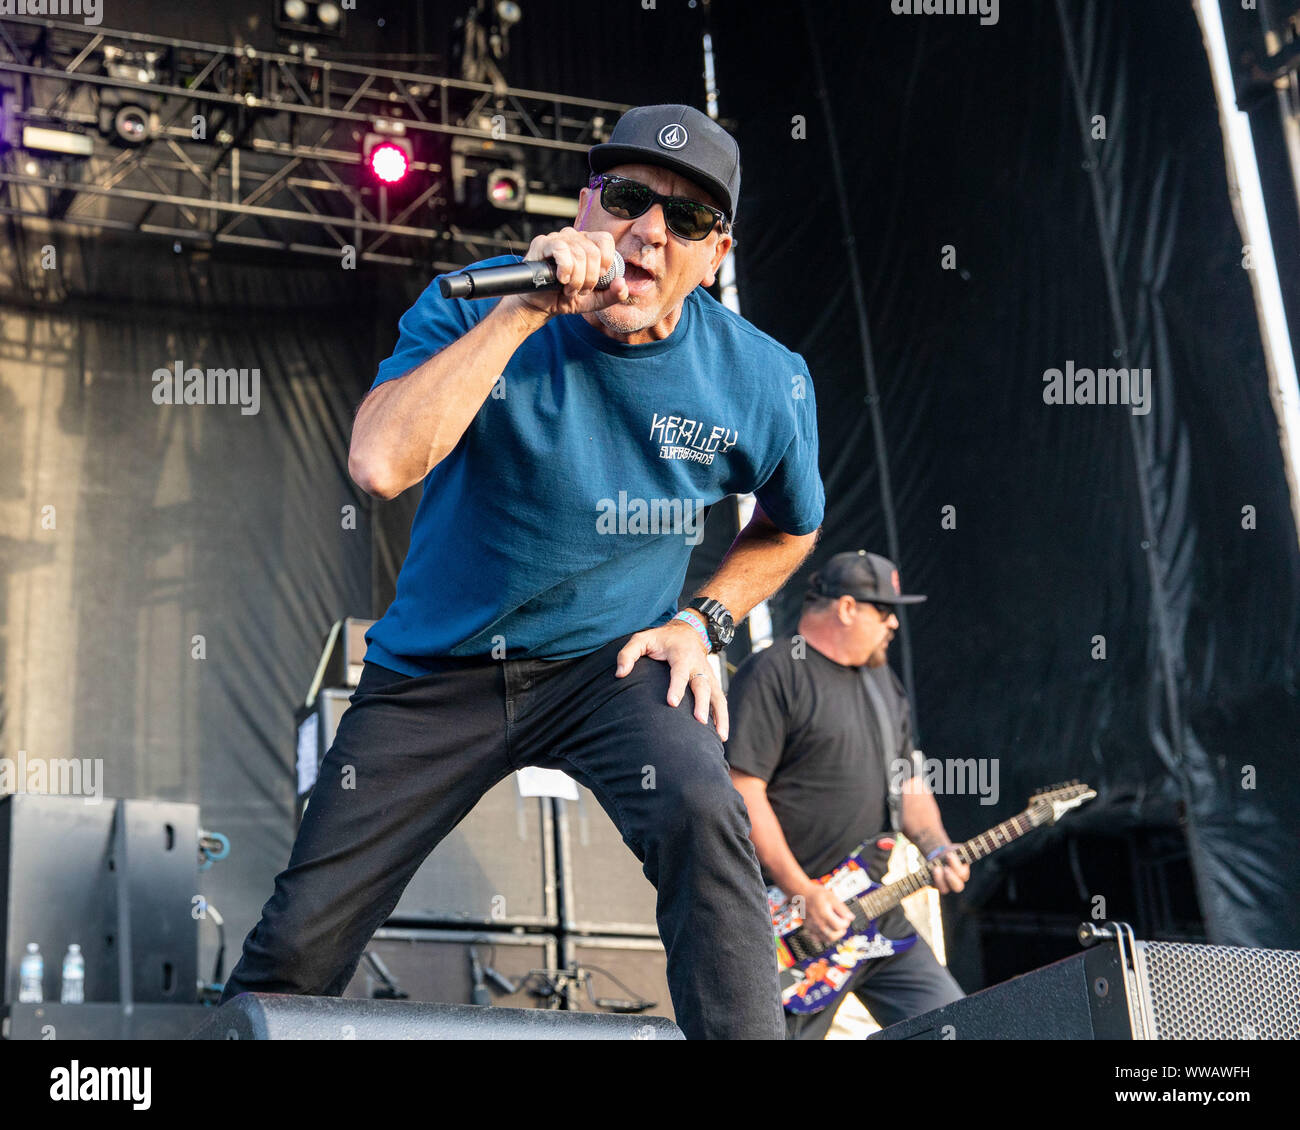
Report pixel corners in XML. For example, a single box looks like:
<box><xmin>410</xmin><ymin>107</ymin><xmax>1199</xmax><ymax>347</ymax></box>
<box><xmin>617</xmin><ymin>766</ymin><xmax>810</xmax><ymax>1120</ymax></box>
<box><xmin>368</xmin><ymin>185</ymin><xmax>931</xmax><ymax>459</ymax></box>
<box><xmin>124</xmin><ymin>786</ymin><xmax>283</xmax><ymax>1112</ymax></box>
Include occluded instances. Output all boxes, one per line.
<box><xmin>1138</xmin><ymin>941</ymin><xmax>1300</xmax><ymax>1040</ymax></box>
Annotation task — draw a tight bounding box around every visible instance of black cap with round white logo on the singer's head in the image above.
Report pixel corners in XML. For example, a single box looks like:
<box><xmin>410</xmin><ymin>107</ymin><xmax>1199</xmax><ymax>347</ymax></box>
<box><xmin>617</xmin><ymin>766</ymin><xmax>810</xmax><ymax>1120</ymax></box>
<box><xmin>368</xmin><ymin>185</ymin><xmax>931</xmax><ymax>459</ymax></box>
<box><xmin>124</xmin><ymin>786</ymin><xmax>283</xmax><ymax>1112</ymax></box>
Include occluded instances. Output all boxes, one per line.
<box><xmin>586</xmin><ymin>105</ymin><xmax>740</xmax><ymax>222</ymax></box>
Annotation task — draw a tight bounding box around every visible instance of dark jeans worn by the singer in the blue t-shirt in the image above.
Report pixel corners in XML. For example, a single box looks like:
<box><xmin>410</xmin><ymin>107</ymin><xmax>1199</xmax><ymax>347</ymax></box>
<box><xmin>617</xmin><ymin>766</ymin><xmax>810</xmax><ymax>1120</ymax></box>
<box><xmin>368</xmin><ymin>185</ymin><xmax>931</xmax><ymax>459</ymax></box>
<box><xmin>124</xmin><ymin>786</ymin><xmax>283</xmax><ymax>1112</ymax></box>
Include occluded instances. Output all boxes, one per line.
<box><xmin>221</xmin><ymin>637</ymin><xmax>785</xmax><ymax>1039</ymax></box>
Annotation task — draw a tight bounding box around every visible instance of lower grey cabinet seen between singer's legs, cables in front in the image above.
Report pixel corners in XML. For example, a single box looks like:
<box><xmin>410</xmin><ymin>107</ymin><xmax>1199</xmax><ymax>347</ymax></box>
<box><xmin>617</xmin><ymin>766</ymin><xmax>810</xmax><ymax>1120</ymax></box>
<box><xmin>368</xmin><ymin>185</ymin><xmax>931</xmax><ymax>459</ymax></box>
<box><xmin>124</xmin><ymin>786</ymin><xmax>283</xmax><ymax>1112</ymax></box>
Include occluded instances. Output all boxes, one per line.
<box><xmin>343</xmin><ymin>928</ymin><xmax>558</xmax><ymax>1008</ymax></box>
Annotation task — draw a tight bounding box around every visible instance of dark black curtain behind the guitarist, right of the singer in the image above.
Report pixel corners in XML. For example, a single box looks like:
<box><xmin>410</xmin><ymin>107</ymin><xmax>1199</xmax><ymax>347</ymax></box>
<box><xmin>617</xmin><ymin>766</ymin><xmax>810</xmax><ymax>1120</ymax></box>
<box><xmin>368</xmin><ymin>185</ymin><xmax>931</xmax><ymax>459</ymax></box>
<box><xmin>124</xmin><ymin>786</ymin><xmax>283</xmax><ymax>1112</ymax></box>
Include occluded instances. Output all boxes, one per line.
<box><xmin>715</xmin><ymin>0</ymin><xmax>1300</xmax><ymax>947</ymax></box>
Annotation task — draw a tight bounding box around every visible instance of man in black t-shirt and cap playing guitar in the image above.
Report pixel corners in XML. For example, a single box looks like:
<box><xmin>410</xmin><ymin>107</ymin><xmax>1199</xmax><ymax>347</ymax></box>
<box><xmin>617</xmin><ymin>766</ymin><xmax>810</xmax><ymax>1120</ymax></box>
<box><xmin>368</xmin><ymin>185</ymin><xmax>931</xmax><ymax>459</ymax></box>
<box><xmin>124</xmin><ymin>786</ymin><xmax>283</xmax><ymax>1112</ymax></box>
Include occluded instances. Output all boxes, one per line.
<box><xmin>727</xmin><ymin>550</ymin><xmax>970</xmax><ymax>1039</ymax></box>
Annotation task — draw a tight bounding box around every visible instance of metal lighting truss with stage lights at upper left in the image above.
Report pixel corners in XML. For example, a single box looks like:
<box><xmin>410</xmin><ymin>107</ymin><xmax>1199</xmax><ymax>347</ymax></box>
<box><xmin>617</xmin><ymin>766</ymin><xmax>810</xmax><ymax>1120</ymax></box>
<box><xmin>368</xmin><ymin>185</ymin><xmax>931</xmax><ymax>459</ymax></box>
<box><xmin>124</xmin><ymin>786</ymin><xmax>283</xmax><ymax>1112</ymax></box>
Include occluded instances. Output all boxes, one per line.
<box><xmin>0</xmin><ymin>17</ymin><xmax>628</xmax><ymax>270</ymax></box>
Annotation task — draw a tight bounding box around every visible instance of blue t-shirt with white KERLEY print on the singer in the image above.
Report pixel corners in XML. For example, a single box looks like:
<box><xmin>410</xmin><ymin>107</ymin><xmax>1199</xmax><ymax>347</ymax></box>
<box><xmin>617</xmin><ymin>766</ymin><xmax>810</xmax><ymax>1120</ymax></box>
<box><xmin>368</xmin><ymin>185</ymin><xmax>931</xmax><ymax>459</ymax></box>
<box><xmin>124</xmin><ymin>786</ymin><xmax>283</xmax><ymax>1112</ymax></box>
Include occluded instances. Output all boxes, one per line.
<box><xmin>365</xmin><ymin>256</ymin><xmax>826</xmax><ymax>675</ymax></box>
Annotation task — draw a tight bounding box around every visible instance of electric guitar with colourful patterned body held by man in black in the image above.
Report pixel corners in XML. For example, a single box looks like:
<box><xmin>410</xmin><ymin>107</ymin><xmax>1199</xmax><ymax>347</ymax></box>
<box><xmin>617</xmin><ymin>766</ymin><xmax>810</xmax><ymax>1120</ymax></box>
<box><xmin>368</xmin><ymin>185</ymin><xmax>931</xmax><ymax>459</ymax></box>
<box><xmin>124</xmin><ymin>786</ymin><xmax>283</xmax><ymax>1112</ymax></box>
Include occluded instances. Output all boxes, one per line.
<box><xmin>767</xmin><ymin>782</ymin><xmax>1097</xmax><ymax>1014</ymax></box>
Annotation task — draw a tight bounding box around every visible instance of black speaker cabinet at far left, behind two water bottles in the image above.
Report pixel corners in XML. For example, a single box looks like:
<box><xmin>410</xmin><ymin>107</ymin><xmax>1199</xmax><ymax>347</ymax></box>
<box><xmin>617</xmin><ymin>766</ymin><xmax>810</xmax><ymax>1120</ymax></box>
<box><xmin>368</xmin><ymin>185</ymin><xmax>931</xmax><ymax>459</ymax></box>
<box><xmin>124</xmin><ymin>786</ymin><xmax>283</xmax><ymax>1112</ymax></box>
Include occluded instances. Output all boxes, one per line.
<box><xmin>0</xmin><ymin>793</ymin><xmax>199</xmax><ymax>1004</ymax></box>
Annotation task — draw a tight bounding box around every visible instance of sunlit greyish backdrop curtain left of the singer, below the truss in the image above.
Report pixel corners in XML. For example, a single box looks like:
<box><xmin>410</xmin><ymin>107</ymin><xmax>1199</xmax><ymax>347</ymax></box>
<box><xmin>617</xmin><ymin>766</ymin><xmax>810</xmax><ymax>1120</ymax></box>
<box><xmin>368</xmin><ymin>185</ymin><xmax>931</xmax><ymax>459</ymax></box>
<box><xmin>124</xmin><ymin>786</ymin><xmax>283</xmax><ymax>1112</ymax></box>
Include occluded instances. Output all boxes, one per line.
<box><xmin>0</xmin><ymin>226</ymin><xmax>416</xmax><ymax>973</ymax></box>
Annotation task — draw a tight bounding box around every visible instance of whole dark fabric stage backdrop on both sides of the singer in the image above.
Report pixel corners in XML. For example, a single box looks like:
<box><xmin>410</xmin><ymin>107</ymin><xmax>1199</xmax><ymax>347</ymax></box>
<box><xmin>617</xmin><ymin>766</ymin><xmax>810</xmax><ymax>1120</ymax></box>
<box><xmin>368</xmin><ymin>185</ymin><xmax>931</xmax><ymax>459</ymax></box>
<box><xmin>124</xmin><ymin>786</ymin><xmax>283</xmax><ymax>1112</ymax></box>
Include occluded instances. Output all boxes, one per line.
<box><xmin>0</xmin><ymin>0</ymin><xmax>1300</xmax><ymax>988</ymax></box>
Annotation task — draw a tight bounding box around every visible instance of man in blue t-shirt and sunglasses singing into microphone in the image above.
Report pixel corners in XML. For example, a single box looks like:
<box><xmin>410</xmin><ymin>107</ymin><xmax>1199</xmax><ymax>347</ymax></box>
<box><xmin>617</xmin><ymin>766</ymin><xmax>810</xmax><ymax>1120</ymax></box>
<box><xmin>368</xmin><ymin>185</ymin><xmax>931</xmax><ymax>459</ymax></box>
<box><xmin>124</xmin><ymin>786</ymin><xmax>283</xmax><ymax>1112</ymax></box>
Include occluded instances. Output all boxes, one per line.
<box><xmin>224</xmin><ymin>105</ymin><xmax>824</xmax><ymax>1039</ymax></box>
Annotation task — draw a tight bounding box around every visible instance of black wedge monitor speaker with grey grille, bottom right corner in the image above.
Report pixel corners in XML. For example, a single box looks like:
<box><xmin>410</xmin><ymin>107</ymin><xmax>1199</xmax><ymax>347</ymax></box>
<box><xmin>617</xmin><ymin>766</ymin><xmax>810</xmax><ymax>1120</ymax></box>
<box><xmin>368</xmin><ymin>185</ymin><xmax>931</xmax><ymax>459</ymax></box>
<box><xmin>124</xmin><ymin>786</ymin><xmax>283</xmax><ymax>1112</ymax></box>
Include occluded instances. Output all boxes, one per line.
<box><xmin>868</xmin><ymin>941</ymin><xmax>1300</xmax><ymax>1040</ymax></box>
